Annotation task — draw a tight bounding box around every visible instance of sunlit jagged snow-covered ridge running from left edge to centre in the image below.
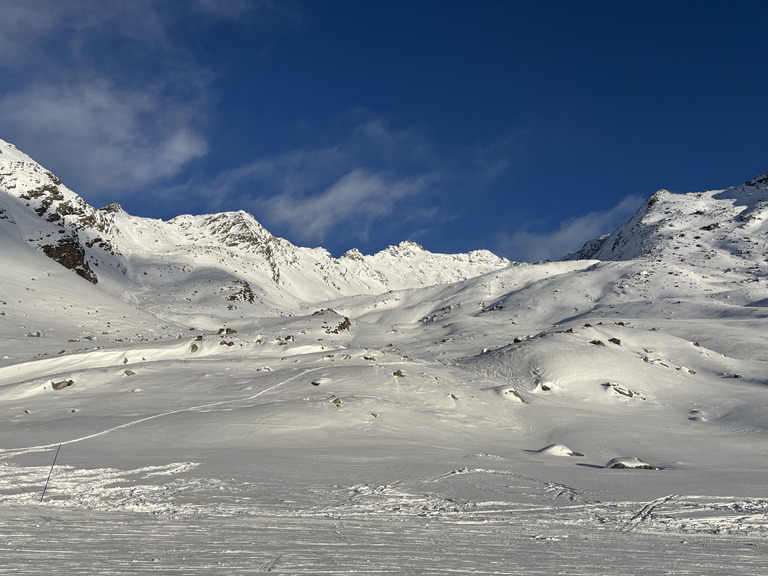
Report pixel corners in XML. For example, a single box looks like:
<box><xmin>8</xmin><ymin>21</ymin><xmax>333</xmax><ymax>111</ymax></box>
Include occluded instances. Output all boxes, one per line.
<box><xmin>0</xmin><ymin>140</ymin><xmax>509</xmax><ymax>320</ymax></box>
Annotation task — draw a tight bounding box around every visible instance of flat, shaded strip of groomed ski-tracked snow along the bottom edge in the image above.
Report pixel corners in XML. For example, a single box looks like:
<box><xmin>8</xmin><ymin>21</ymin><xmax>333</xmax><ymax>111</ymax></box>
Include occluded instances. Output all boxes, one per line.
<box><xmin>0</xmin><ymin>496</ymin><xmax>768</xmax><ymax>576</ymax></box>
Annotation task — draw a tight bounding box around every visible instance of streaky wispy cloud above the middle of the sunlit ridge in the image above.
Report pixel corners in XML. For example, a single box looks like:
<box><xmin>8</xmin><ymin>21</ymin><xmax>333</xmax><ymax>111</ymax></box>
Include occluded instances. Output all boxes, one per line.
<box><xmin>194</xmin><ymin>115</ymin><xmax>447</xmax><ymax>243</ymax></box>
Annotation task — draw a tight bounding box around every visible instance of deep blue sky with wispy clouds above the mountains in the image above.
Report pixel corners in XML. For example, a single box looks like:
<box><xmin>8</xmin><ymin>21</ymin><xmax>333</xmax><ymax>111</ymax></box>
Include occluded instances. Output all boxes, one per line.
<box><xmin>0</xmin><ymin>0</ymin><xmax>768</xmax><ymax>261</ymax></box>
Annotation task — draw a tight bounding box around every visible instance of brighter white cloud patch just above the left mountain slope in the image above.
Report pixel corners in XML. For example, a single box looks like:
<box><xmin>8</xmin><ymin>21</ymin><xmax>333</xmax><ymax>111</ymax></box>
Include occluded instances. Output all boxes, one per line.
<box><xmin>0</xmin><ymin>81</ymin><xmax>207</xmax><ymax>196</ymax></box>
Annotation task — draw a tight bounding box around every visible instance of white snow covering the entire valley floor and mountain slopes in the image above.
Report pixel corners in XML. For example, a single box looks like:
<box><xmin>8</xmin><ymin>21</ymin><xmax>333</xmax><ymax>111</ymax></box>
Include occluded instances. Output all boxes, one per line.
<box><xmin>0</xmin><ymin>142</ymin><xmax>768</xmax><ymax>575</ymax></box>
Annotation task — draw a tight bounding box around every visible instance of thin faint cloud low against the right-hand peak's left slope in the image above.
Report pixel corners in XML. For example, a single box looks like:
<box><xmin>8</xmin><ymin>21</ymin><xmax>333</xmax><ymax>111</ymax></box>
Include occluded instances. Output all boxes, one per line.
<box><xmin>497</xmin><ymin>195</ymin><xmax>643</xmax><ymax>262</ymax></box>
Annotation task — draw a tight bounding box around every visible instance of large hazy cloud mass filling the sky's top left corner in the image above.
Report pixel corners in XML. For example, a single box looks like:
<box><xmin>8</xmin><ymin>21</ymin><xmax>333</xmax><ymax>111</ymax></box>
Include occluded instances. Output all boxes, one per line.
<box><xmin>0</xmin><ymin>0</ymin><xmax>295</xmax><ymax>201</ymax></box>
